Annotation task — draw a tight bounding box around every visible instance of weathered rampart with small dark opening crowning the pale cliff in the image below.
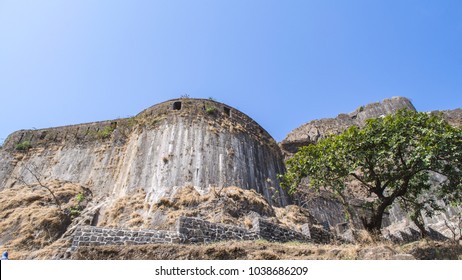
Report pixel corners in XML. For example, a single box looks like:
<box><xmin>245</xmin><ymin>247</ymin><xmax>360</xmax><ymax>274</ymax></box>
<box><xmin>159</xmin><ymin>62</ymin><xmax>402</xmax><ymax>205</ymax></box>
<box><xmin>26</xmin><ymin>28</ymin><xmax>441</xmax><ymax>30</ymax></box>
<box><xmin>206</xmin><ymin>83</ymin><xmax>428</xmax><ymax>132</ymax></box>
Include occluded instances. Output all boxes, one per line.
<box><xmin>3</xmin><ymin>98</ymin><xmax>279</xmax><ymax>152</ymax></box>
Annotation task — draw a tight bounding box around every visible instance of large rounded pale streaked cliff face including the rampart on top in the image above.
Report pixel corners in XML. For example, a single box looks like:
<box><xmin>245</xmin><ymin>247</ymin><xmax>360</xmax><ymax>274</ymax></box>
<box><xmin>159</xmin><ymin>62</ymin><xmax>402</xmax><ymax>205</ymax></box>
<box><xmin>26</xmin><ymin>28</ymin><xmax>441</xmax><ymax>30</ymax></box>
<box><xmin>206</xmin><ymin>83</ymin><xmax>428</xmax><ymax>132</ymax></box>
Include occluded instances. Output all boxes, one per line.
<box><xmin>0</xmin><ymin>99</ymin><xmax>288</xmax><ymax>205</ymax></box>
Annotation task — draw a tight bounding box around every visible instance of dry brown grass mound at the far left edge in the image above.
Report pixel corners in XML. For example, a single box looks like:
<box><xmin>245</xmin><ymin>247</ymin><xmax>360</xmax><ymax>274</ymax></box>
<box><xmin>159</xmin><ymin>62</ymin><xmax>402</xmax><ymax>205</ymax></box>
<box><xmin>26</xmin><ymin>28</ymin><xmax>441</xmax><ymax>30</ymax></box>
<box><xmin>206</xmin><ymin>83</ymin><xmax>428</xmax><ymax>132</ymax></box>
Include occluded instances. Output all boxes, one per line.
<box><xmin>0</xmin><ymin>181</ymin><xmax>84</xmax><ymax>258</ymax></box>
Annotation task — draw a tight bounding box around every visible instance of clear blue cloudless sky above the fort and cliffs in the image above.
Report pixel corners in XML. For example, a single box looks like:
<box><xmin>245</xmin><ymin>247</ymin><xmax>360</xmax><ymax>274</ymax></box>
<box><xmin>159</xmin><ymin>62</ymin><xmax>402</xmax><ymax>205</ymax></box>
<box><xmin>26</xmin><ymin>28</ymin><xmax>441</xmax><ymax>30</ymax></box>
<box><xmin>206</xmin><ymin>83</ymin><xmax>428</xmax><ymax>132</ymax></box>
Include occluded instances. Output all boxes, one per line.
<box><xmin>0</xmin><ymin>0</ymin><xmax>462</xmax><ymax>143</ymax></box>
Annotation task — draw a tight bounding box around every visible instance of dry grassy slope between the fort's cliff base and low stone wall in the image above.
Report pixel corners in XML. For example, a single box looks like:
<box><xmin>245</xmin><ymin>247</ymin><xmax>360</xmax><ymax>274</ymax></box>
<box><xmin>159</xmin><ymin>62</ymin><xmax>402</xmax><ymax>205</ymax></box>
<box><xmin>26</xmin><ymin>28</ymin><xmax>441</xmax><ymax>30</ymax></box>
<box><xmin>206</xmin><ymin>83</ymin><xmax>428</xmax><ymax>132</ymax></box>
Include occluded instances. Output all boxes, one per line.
<box><xmin>0</xmin><ymin>181</ymin><xmax>317</xmax><ymax>259</ymax></box>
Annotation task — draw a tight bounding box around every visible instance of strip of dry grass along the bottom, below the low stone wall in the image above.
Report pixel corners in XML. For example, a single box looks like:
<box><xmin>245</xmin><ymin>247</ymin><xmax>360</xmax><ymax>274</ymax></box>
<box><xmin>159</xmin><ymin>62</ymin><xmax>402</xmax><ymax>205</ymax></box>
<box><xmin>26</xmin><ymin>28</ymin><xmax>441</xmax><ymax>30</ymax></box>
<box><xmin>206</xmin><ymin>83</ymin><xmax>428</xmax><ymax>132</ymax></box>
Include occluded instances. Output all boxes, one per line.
<box><xmin>72</xmin><ymin>238</ymin><xmax>462</xmax><ymax>260</ymax></box>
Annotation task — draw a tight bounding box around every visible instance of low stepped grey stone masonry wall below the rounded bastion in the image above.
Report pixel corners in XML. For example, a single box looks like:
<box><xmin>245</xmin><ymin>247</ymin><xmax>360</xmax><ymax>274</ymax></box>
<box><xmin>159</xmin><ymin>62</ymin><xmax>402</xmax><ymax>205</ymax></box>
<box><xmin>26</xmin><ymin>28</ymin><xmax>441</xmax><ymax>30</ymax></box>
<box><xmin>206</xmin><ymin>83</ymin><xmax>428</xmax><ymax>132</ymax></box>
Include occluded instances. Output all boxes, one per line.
<box><xmin>72</xmin><ymin>217</ymin><xmax>331</xmax><ymax>250</ymax></box>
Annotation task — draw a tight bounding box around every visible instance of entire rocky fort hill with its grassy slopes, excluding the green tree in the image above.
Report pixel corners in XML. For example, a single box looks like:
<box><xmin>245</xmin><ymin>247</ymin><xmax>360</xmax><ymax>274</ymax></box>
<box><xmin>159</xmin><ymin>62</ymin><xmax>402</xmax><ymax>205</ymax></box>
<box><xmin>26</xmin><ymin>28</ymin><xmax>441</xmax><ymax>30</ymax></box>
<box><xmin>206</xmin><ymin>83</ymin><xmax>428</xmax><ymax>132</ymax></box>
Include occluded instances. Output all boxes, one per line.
<box><xmin>0</xmin><ymin>97</ymin><xmax>462</xmax><ymax>259</ymax></box>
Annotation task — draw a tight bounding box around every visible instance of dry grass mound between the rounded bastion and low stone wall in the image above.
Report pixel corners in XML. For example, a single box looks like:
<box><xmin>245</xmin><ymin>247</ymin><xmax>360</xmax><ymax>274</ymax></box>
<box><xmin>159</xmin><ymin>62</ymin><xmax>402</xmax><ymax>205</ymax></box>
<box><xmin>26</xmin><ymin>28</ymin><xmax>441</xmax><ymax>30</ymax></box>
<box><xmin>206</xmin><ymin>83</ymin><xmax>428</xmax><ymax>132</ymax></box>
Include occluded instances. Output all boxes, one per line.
<box><xmin>98</xmin><ymin>186</ymin><xmax>280</xmax><ymax>229</ymax></box>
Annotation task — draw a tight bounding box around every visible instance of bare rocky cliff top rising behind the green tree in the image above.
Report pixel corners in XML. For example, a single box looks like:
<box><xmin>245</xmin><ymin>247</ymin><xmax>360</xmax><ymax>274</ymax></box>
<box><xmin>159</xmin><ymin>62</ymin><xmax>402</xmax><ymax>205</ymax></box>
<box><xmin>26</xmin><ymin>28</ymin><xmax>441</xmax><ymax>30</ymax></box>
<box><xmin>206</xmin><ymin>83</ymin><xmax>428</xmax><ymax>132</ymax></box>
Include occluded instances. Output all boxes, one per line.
<box><xmin>280</xmin><ymin>97</ymin><xmax>415</xmax><ymax>156</ymax></box>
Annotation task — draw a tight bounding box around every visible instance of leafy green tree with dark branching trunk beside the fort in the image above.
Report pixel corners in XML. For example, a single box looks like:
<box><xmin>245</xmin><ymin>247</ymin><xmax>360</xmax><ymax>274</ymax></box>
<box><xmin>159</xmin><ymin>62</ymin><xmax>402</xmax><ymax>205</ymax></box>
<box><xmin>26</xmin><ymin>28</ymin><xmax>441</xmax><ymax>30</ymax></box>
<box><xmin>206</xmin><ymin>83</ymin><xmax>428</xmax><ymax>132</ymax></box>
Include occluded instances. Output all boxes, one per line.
<box><xmin>281</xmin><ymin>110</ymin><xmax>462</xmax><ymax>231</ymax></box>
